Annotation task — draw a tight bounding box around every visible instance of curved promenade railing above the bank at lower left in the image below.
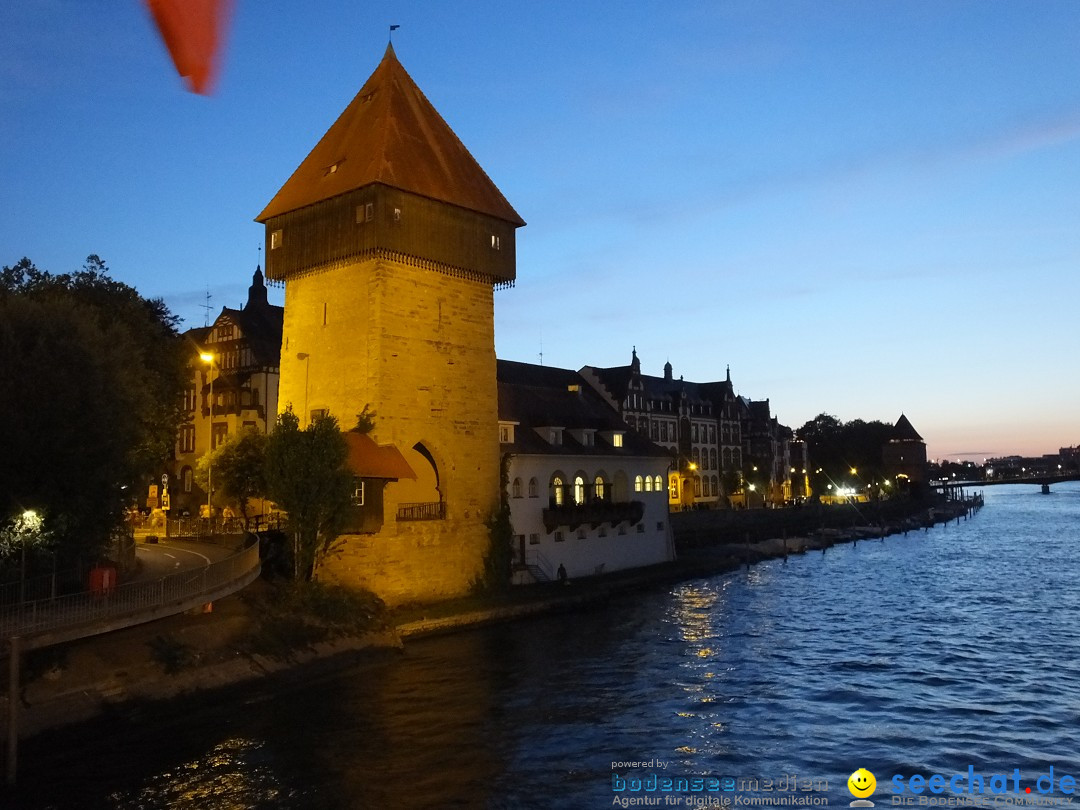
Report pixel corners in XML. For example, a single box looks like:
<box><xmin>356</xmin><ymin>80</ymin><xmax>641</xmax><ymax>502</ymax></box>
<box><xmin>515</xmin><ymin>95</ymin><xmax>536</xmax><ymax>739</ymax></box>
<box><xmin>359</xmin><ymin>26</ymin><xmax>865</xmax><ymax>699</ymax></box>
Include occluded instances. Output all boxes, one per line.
<box><xmin>0</xmin><ymin>537</ymin><xmax>260</xmax><ymax>649</ymax></box>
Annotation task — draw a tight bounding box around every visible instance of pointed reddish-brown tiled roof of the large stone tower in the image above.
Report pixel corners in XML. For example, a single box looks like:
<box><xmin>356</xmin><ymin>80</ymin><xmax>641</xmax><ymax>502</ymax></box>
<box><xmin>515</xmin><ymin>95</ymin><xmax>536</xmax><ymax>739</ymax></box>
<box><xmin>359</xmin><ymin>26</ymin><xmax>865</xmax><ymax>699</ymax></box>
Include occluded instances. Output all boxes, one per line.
<box><xmin>256</xmin><ymin>45</ymin><xmax>525</xmax><ymax>226</ymax></box>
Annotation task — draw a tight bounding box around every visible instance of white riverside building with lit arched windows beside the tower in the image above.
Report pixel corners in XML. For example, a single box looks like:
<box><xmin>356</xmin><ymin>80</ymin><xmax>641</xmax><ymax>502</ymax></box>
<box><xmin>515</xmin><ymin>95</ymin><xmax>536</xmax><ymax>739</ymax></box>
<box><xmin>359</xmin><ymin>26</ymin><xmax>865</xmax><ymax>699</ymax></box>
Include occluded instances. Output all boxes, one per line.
<box><xmin>498</xmin><ymin>360</ymin><xmax>674</xmax><ymax>583</ymax></box>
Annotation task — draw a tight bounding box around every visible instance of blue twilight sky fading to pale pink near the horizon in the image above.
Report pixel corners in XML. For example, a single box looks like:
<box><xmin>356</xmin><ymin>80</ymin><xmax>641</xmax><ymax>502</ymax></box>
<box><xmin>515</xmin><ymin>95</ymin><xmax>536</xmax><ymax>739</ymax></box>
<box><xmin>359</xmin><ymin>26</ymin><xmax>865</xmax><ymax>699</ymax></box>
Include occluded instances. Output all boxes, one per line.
<box><xmin>0</xmin><ymin>0</ymin><xmax>1080</xmax><ymax>461</ymax></box>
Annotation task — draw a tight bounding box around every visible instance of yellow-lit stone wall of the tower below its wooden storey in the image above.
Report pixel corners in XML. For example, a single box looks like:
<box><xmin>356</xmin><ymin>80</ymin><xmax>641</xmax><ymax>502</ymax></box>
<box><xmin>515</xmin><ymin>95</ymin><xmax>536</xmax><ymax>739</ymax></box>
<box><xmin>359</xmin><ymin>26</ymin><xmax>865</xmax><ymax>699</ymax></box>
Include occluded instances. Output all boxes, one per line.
<box><xmin>279</xmin><ymin>259</ymin><xmax>499</xmax><ymax>604</ymax></box>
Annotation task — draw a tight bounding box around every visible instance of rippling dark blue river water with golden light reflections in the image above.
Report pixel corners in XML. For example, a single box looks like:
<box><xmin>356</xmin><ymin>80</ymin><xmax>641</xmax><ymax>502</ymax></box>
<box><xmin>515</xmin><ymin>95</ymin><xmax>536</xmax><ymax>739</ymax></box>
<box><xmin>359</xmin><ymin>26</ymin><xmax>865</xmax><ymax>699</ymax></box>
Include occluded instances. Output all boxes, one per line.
<box><xmin>10</xmin><ymin>483</ymin><xmax>1080</xmax><ymax>810</ymax></box>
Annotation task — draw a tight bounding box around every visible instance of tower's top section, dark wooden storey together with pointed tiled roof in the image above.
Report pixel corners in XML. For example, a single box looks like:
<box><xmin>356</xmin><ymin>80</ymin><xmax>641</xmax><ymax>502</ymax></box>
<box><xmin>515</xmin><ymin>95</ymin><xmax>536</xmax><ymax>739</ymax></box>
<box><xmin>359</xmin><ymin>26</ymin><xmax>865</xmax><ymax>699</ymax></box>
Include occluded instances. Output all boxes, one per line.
<box><xmin>256</xmin><ymin>46</ymin><xmax>525</xmax><ymax>284</ymax></box>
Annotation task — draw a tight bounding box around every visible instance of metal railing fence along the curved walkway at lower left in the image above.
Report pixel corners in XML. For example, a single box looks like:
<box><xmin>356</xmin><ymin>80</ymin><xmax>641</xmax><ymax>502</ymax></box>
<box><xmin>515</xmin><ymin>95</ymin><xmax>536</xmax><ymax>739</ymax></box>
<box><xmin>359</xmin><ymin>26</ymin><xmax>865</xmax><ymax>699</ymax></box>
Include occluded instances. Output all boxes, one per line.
<box><xmin>0</xmin><ymin>538</ymin><xmax>259</xmax><ymax>638</ymax></box>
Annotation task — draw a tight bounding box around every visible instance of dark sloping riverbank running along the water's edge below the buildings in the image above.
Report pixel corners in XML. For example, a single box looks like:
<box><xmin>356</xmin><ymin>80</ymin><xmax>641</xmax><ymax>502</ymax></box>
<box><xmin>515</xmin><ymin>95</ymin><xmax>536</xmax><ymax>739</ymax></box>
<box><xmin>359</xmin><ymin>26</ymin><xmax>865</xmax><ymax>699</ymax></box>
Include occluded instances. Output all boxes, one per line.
<box><xmin>0</xmin><ymin>502</ymin><xmax>976</xmax><ymax>738</ymax></box>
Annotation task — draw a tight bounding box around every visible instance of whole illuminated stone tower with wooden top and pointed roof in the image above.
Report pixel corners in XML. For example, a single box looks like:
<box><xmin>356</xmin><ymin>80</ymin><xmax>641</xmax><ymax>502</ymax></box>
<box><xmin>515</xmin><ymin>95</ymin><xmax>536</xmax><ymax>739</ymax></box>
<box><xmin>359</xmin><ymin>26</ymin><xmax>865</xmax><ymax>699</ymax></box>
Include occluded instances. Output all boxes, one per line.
<box><xmin>256</xmin><ymin>42</ymin><xmax>525</xmax><ymax>604</ymax></box>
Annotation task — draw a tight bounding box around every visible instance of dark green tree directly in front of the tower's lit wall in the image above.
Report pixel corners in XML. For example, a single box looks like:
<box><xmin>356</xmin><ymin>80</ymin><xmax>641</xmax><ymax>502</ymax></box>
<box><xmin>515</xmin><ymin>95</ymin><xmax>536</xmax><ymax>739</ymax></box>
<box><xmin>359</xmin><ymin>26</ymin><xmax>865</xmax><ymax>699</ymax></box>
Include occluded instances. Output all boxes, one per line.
<box><xmin>266</xmin><ymin>409</ymin><xmax>352</xmax><ymax>580</ymax></box>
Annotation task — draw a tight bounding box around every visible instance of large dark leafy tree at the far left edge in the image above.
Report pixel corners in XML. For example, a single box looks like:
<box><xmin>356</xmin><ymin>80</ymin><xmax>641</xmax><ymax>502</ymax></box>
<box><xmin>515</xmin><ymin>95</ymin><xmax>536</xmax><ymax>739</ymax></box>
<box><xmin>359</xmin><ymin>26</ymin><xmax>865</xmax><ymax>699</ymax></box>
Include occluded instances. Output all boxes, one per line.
<box><xmin>0</xmin><ymin>256</ymin><xmax>187</xmax><ymax>556</ymax></box>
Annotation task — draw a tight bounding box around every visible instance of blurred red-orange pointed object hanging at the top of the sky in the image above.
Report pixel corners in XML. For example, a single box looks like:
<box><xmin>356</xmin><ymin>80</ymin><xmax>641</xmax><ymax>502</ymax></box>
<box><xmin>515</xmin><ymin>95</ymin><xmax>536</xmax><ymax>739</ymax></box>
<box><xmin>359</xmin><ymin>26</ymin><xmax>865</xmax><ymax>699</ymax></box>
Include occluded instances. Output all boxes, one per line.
<box><xmin>145</xmin><ymin>0</ymin><xmax>232</xmax><ymax>95</ymax></box>
